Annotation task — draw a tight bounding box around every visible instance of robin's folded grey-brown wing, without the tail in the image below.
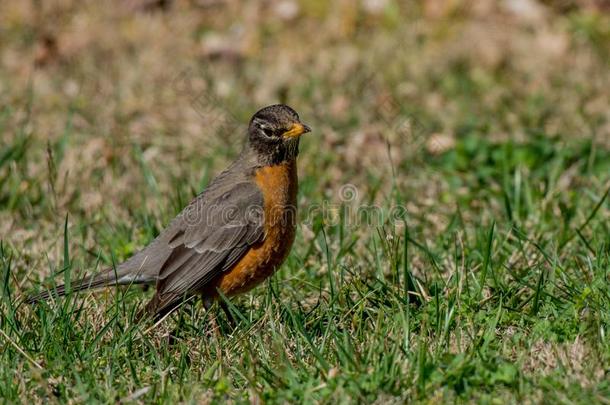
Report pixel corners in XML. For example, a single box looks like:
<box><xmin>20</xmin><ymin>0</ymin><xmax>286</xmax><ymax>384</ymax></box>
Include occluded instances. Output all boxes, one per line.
<box><xmin>157</xmin><ymin>182</ymin><xmax>264</xmax><ymax>304</ymax></box>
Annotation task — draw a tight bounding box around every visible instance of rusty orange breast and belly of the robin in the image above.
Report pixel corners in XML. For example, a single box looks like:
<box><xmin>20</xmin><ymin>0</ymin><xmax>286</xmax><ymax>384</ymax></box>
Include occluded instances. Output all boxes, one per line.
<box><xmin>214</xmin><ymin>160</ymin><xmax>298</xmax><ymax>296</ymax></box>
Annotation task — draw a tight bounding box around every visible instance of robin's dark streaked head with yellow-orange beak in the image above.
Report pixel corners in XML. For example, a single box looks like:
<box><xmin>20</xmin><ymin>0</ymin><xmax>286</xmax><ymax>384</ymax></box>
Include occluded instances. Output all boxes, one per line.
<box><xmin>248</xmin><ymin>104</ymin><xmax>311</xmax><ymax>163</ymax></box>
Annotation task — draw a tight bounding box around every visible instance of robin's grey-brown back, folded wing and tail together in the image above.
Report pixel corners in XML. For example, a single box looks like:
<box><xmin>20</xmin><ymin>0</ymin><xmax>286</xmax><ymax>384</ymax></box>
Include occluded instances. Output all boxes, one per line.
<box><xmin>26</xmin><ymin>160</ymin><xmax>264</xmax><ymax>312</ymax></box>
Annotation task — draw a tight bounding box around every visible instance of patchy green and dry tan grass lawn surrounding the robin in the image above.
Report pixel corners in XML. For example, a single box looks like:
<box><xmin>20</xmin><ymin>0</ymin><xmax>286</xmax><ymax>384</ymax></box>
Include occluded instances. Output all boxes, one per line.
<box><xmin>0</xmin><ymin>1</ymin><xmax>610</xmax><ymax>403</ymax></box>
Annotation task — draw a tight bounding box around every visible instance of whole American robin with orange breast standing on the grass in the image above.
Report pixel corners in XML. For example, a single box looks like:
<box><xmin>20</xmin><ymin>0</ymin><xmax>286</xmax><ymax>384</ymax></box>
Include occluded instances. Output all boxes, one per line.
<box><xmin>27</xmin><ymin>104</ymin><xmax>311</xmax><ymax>318</ymax></box>
